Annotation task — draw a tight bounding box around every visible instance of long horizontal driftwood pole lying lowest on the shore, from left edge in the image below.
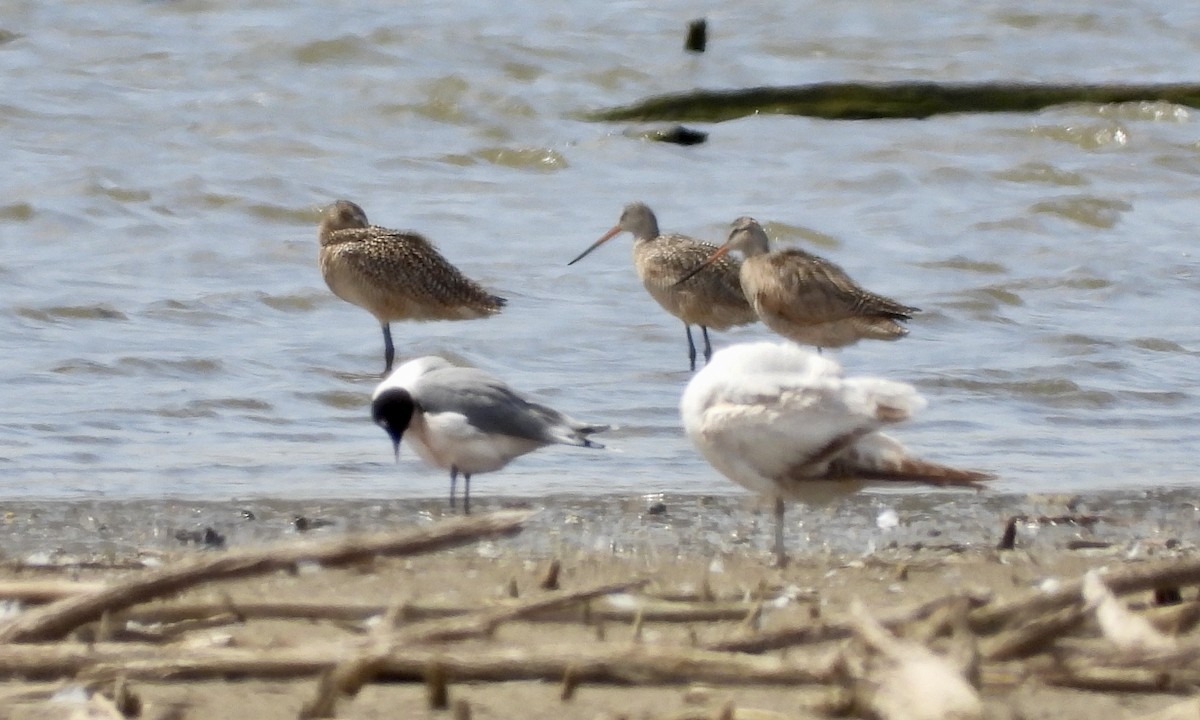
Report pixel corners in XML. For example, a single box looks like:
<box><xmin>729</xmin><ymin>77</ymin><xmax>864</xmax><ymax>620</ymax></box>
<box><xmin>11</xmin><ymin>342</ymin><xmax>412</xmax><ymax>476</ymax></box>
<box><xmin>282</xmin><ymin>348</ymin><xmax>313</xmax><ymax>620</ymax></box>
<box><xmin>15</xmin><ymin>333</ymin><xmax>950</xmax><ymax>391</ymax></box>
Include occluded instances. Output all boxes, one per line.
<box><xmin>9</xmin><ymin>642</ymin><xmax>835</xmax><ymax>685</ymax></box>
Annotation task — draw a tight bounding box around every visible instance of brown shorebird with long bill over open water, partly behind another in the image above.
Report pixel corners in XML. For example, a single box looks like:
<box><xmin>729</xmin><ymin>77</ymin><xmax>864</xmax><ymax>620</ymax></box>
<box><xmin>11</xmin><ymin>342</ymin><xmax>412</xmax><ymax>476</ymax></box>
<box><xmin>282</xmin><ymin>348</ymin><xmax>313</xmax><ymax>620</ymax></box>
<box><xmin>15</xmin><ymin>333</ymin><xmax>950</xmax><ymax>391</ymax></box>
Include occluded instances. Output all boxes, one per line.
<box><xmin>568</xmin><ymin>203</ymin><xmax>757</xmax><ymax>370</ymax></box>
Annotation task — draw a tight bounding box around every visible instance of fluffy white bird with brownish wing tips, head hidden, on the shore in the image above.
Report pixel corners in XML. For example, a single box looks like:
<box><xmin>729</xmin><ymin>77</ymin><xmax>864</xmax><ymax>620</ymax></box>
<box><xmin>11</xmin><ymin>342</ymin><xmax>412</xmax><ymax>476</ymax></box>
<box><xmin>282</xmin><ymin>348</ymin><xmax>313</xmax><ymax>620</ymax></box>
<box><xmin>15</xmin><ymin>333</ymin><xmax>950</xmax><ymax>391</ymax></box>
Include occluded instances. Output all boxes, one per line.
<box><xmin>679</xmin><ymin>342</ymin><xmax>991</xmax><ymax>564</ymax></box>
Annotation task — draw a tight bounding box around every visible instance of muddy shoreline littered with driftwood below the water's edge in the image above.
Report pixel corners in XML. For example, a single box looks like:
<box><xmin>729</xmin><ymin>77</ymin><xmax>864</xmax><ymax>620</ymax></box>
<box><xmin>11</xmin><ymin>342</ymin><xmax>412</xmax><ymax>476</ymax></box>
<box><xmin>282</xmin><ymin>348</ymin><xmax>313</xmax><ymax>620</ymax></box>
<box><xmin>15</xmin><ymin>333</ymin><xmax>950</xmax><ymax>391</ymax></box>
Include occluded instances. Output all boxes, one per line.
<box><xmin>0</xmin><ymin>492</ymin><xmax>1200</xmax><ymax>720</ymax></box>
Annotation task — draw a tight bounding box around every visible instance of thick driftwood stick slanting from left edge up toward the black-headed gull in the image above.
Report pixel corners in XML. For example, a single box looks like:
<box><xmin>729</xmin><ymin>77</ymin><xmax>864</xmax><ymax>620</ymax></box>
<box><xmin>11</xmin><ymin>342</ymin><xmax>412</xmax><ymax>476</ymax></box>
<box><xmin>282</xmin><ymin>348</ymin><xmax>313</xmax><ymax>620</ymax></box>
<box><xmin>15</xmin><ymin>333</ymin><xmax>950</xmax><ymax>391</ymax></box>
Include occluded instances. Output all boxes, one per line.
<box><xmin>0</xmin><ymin>510</ymin><xmax>535</xmax><ymax>643</ymax></box>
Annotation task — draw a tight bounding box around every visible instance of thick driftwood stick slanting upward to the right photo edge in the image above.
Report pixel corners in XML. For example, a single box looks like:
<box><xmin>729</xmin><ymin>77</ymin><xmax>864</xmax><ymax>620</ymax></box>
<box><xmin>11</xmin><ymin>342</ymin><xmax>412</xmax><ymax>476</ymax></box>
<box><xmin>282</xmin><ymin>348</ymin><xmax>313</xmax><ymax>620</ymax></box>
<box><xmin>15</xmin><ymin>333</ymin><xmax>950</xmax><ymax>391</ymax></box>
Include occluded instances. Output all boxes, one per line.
<box><xmin>970</xmin><ymin>558</ymin><xmax>1200</xmax><ymax>634</ymax></box>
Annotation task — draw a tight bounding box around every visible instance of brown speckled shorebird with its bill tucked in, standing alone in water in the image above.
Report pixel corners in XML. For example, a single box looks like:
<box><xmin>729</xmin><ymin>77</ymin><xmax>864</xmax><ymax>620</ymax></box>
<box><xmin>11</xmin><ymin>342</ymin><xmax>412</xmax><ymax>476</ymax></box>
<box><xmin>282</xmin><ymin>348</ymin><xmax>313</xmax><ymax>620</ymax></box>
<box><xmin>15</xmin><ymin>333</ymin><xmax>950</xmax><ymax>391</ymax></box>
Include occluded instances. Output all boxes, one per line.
<box><xmin>317</xmin><ymin>200</ymin><xmax>505</xmax><ymax>373</ymax></box>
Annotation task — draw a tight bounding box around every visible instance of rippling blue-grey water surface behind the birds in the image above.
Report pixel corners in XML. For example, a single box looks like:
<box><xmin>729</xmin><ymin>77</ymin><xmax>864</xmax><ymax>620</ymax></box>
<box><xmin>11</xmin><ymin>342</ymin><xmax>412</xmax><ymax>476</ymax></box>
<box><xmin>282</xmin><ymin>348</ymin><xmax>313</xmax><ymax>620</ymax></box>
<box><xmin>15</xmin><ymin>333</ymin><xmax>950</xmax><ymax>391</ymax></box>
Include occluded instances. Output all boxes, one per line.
<box><xmin>0</xmin><ymin>0</ymin><xmax>1200</xmax><ymax>499</ymax></box>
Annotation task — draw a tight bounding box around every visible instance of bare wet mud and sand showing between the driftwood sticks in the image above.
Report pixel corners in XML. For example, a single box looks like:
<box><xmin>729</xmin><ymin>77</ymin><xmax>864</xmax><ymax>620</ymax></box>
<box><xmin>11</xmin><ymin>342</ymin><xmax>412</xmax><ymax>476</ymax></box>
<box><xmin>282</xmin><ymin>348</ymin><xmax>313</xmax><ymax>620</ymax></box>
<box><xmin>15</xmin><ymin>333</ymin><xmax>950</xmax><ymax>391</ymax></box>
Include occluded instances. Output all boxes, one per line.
<box><xmin>0</xmin><ymin>493</ymin><xmax>1195</xmax><ymax>720</ymax></box>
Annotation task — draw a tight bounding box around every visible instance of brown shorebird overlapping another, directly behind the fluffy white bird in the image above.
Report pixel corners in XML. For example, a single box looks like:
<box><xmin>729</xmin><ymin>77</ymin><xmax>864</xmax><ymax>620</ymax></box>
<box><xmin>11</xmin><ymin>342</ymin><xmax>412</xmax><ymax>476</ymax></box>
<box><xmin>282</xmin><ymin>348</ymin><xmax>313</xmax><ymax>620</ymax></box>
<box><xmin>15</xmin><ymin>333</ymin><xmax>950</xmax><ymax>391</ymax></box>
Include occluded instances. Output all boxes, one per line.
<box><xmin>679</xmin><ymin>217</ymin><xmax>920</xmax><ymax>348</ymax></box>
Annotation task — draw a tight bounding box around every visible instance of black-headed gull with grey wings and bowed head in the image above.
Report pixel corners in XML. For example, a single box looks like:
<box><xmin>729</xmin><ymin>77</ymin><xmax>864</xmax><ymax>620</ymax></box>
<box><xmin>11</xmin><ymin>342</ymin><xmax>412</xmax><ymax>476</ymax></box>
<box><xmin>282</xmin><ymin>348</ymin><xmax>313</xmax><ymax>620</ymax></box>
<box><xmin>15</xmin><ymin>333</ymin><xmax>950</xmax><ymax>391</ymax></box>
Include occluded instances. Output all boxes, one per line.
<box><xmin>371</xmin><ymin>355</ymin><xmax>608</xmax><ymax>515</ymax></box>
